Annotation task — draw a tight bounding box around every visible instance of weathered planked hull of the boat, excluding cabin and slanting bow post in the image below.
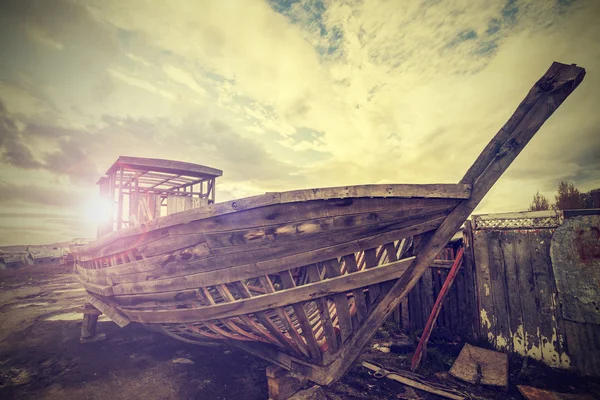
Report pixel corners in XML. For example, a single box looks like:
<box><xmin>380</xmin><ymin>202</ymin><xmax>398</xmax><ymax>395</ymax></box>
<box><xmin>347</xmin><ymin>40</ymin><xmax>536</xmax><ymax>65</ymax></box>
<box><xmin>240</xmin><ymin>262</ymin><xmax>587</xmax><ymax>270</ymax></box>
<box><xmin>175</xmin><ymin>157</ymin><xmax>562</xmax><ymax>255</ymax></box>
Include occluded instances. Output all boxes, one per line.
<box><xmin>76</xmin><ymin>191</ymin><xmax>470</xmax><ymax>350</ymax></box>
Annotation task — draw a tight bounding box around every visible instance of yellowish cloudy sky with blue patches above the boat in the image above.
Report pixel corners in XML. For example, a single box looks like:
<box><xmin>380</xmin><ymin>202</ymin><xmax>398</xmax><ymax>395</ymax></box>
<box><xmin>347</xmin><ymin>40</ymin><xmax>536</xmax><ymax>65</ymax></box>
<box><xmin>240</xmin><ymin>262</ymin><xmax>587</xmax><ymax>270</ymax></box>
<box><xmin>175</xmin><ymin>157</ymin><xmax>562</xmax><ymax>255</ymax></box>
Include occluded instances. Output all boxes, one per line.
<box><xmin>0</xmin><ymin>0</ymin><xmax>600</xmax><ymax>244</ymax></box>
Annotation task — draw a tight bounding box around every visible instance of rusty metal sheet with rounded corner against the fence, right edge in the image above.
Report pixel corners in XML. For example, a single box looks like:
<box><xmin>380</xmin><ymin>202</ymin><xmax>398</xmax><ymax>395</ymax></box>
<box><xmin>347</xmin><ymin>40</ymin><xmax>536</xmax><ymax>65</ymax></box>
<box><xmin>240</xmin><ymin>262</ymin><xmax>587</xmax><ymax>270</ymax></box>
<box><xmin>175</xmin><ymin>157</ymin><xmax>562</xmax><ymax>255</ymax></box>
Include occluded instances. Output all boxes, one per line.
<box><xmin>550</xmin><ymin>215</ymin><xmax>600</xmax><ymax>324</ymax></box>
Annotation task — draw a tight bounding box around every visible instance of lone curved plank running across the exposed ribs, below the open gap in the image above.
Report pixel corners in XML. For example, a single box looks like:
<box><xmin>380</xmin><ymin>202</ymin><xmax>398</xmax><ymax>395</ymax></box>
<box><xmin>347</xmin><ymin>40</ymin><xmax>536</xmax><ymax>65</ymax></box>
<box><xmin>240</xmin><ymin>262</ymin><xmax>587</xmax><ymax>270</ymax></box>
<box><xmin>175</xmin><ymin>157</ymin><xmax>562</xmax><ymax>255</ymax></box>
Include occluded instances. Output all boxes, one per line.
<box><xmin>120</xmin><ymin>257</ymin><xmax>413</xmax><ymax>323</ymax></box>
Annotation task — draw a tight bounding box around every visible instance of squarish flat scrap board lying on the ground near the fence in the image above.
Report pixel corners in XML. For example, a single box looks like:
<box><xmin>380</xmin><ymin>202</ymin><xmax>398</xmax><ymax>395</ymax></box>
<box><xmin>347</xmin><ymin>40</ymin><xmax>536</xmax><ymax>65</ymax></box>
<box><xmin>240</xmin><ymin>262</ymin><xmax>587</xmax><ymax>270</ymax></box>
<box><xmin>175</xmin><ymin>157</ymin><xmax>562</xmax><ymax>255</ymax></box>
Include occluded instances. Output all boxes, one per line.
<box><xmin>450</xmin><ymin>343</ymin><xmax>508</xmax><ymax>388</ymax></box>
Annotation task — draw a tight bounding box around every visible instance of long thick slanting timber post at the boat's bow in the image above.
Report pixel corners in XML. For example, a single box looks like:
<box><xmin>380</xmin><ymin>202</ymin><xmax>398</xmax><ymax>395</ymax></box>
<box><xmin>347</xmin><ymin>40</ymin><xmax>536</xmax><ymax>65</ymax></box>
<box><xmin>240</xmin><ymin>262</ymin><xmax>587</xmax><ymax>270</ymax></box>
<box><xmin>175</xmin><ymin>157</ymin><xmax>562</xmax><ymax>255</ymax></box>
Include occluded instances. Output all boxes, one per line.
<box><xmin>311</xmin><ymin>62</ymin><xmax>585</xmax><ymax>384</ymax></box>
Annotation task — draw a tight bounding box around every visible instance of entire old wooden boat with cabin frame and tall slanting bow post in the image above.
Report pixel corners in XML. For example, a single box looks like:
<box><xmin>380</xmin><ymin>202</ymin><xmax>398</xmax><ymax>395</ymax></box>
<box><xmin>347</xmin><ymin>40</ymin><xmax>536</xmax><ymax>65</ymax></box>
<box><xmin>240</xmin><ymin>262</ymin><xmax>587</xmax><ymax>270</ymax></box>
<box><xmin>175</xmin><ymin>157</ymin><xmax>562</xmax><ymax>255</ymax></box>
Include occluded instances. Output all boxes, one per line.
<box><xmin>72</xmin><ymin>63</ymin><xmax>585</xmax><ymax>384</ymax></box>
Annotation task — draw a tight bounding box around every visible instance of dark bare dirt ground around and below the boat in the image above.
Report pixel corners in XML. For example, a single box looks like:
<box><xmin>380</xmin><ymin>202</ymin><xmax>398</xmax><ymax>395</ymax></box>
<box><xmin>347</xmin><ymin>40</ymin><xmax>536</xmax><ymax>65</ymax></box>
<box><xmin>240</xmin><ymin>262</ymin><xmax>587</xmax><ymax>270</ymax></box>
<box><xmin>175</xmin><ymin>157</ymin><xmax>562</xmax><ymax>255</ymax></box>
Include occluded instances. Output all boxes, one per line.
<box><xmin>0</xmin><ymin>266</ymin><xmax>600</xmax><ymax>400</ymax></box>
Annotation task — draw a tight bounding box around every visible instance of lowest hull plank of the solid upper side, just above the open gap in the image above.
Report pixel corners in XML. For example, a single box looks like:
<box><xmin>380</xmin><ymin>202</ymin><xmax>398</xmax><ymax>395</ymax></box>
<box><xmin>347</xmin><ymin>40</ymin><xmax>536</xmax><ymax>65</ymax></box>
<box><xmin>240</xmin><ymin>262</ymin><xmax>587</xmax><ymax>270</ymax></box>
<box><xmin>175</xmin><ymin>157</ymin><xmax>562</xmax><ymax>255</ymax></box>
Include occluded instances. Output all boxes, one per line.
<box><xmin>109</xmin><ymin>221</ymin><xmax>439</xmax><ymax>294</ymax></box>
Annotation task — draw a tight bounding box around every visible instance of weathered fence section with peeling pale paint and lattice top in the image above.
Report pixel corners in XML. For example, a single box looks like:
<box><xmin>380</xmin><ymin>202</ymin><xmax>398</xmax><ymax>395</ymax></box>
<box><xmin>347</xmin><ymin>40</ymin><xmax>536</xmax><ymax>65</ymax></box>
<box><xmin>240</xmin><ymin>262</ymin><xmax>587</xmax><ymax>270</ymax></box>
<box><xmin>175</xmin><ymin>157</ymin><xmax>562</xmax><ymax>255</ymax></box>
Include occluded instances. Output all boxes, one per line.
<box><xmin>466</xmin><ymin>212</ymin><xmax>600</xmax><ymax>376</ymax></box>
